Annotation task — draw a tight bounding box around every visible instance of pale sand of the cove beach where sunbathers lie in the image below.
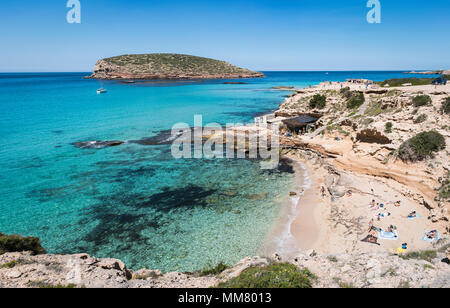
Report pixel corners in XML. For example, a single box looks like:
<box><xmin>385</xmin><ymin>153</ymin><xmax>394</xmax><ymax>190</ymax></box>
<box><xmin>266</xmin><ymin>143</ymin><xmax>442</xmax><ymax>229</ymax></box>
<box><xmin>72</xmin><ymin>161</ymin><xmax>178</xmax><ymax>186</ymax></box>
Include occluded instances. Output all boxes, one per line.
<box><xmin>278</xmin><ymin>152</ymin><xmax>436</xmax><ymax>257</ymax></box>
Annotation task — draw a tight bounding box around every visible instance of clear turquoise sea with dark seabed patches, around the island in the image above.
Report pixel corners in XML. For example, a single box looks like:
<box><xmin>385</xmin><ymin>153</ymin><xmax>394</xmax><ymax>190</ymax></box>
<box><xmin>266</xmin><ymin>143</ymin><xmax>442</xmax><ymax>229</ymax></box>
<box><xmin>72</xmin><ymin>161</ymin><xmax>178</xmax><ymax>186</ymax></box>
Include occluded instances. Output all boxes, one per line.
<box><xmin>0</xmin><ymin>72</ymin><xmax>432</xmax><ymax>271</ymax></box>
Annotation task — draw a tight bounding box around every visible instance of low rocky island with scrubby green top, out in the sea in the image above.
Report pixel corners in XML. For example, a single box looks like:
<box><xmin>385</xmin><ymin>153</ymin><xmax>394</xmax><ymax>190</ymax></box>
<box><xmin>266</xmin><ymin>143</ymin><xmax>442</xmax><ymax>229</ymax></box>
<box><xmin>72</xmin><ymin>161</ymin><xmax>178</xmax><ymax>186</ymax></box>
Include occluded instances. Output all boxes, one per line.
<box><xmin>87</xmin><ymin>53</ymin><xmax>264</xmax><ymax>80</ymax></box>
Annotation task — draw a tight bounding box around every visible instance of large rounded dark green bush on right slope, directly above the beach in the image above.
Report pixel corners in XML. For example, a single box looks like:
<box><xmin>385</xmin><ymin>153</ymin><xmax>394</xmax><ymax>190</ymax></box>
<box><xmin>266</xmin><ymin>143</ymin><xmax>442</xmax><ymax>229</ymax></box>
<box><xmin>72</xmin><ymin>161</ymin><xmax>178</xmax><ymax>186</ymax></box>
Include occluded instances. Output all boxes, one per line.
<box><xmin>398</xmin><ymin>131</ymin><xmax>446</xmax><ymax>162</ymax></box>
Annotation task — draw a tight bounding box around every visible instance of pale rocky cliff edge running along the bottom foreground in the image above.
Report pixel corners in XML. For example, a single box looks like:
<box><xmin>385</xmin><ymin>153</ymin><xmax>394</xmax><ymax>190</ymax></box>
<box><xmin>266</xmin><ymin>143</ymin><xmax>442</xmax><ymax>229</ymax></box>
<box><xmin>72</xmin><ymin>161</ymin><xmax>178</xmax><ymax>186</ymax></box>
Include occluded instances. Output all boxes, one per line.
<box><xmin>0</xmin><ymin>246</ymin><xmax>450</xmax><ymax>288</ymax></box>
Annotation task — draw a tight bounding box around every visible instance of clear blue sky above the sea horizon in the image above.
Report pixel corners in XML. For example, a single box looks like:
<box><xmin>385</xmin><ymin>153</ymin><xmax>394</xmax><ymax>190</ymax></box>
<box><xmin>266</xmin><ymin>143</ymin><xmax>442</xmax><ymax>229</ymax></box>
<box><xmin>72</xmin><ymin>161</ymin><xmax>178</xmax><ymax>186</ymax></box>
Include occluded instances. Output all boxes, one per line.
<box><xmin>0</xmin><ymin>0</ymin><xmax>450</xmax><ymax>72</ymax></box>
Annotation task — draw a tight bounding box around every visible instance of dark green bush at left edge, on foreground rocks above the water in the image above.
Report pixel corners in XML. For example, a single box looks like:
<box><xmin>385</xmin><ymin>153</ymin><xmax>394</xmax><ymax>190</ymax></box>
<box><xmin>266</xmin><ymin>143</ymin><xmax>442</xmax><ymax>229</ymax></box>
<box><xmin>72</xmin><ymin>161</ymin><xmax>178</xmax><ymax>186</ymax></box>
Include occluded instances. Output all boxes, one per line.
<box><xmin>0</xmin><ymin>233</ymin><xmax>45</xmax><ymax>255</ymax></box>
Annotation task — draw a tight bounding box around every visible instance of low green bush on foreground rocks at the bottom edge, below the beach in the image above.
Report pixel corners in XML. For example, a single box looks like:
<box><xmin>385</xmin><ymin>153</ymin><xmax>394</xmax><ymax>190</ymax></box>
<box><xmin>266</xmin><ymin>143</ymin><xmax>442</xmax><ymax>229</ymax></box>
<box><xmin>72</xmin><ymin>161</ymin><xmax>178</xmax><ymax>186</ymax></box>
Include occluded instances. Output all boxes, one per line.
<box><xmin>219</xmin><ymin>263</ymin><xmax>316</xmax><ymax>289</ymax></box>
